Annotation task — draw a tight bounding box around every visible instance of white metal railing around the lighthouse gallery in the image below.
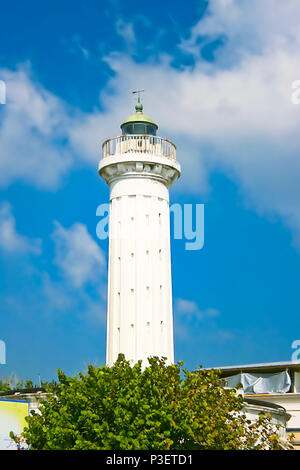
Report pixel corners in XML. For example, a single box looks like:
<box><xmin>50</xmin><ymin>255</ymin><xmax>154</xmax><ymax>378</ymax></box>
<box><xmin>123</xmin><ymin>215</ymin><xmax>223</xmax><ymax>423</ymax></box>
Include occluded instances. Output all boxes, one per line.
<box><xmin>102</xmin><ymin>134</ymin><xmax>176</xmax><ymax>160</ymax></box>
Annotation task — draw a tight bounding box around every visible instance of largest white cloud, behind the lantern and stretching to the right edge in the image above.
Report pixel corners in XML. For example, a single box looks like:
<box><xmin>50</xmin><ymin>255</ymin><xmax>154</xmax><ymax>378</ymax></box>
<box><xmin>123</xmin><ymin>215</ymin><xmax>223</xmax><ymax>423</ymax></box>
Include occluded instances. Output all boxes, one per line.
<box><xmin>70</xmin><ymin>0</ymin><xmax>300</xmax><ymax>249</ymax></box>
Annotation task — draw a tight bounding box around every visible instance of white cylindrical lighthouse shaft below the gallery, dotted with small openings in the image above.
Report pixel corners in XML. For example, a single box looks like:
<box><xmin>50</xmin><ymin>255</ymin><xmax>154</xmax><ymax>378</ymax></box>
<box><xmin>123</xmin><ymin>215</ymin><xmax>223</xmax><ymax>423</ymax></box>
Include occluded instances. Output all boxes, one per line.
<box><xmin>107</xmin><ymin>177</ymin><xmax>174</xmax><ymax>364</ymax></box>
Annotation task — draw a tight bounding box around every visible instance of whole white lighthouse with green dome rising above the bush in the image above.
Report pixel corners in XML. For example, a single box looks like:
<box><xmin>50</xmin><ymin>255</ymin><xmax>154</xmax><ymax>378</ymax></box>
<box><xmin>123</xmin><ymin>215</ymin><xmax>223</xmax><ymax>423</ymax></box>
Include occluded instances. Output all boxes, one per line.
<box><xmin>99</xmin><ymin>97</ymin><xmax>180</xmax><ymax>366</ymax></box>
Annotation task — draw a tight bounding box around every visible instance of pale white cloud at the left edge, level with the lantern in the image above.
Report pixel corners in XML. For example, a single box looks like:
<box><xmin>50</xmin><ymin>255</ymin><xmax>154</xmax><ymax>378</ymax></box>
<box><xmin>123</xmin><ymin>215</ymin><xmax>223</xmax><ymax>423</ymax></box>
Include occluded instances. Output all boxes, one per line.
<box><xmin>0</xmin><ymin>66</ymin><xmax>72</xmax><ymax>188</ymax></box>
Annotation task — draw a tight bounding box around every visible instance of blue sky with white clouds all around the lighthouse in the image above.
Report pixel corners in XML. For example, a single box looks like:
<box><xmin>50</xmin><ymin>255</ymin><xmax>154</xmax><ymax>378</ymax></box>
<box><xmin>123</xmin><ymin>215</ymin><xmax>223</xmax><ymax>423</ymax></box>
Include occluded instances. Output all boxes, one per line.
<box><xmin>0</xmin><ymin>0</ymin><xmax>300</xmax><ymax>381</ymax></box>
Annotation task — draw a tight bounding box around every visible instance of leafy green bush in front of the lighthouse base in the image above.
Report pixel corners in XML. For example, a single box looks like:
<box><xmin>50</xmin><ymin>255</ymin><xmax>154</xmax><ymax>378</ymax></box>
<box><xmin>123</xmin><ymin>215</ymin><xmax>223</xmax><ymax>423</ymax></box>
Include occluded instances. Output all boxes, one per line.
<box><xmin>18</xmin><ymin>355</ymin><xmax>279</xmax><ymax>450</ymax></box>
